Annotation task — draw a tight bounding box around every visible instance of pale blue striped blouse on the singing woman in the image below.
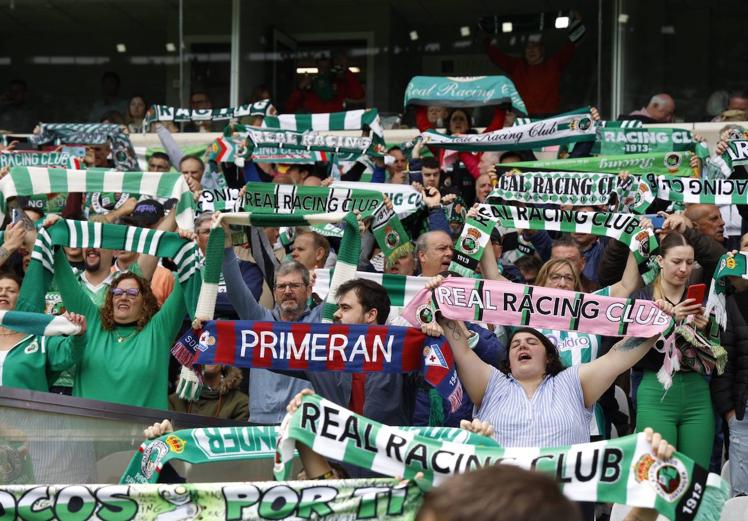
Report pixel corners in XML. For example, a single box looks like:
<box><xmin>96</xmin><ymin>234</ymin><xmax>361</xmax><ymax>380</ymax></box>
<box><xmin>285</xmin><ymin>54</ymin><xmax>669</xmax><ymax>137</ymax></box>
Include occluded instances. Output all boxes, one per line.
<box><xmin>475</xmin><ymin>366</ymin><xmax>592</xmax><ymax>447</ymax></box>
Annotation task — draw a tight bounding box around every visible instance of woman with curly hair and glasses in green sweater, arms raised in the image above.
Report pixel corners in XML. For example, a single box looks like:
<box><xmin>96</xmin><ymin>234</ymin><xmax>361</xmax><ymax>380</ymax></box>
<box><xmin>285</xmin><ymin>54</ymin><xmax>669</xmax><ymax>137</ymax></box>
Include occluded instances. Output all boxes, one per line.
<box><xmin>54</xmin><ymin>248</ymin><xmax>187</xmax><ymax>409</ymax></box>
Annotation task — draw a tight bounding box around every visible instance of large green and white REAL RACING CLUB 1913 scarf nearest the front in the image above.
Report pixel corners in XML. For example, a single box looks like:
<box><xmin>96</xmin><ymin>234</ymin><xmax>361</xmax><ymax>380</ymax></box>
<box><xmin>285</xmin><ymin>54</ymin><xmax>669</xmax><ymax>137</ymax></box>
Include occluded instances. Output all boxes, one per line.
<box><xmin>274</xmin><ymin>395</ymin><xmax>730</xmax><ymax>521</ymax></box>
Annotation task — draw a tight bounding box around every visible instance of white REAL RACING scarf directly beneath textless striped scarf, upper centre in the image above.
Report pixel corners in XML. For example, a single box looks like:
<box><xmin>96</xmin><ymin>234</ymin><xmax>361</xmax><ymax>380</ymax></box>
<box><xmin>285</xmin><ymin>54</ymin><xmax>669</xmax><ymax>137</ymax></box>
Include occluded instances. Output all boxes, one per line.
<box><xmin>246</xmin><ymin>126</ymin><xmax>386</xmax><ymax>157</ymax></box>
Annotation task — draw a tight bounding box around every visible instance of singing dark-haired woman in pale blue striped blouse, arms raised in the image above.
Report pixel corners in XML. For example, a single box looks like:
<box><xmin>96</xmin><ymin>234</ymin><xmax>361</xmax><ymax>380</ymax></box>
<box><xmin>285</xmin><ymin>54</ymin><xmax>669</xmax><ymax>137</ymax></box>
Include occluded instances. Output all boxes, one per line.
<box><xmin>423</xmin><ymin>277</ymin><xmax>659</xmax><ymax>447</ymax></box>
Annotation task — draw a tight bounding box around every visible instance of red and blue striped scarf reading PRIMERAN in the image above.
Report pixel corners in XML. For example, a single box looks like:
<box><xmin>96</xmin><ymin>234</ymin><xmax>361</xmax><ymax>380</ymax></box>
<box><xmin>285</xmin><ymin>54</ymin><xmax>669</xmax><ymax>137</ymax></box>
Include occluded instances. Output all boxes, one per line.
<box><xmin>186</xmin><ymin>320</ymin><xmax>462</xmax><ymax>412</ymax></box>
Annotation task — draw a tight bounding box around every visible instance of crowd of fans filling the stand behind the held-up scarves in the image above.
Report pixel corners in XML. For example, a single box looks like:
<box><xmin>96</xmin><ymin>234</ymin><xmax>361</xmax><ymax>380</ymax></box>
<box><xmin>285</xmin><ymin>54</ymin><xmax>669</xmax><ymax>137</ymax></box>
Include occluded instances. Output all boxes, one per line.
<box><xmin>0</xmin><ymin>28</ymin><xmax>748</xmax><ymax>519</ymax></box>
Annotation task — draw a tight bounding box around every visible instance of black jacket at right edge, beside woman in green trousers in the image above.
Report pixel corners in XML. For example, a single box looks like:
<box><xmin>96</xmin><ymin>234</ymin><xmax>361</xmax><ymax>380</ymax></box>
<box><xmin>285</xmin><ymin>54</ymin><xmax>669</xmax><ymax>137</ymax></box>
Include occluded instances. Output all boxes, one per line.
<box><xmin>711</xmin><ymin>291</ymin><xmax>748</xmax><ymax>420</ymax></box>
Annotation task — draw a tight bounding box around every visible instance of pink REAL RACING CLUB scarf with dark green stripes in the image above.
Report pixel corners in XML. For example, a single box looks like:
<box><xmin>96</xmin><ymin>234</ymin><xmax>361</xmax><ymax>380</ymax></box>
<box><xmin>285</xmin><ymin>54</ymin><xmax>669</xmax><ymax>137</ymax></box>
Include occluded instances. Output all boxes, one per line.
<box><xmin>402</xmin><ymin>277</ymin><xmax>674</xmax><ymax>338</ymax></box>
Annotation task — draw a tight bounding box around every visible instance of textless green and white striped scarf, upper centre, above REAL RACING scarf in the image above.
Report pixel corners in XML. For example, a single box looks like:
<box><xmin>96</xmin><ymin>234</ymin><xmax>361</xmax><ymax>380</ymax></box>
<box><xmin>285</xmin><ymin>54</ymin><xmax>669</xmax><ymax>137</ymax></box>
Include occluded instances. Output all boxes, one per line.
<box><xmin>262</xmin><ymin>109</ymin><xmax>384</xmax><ymax>143</ymax></box>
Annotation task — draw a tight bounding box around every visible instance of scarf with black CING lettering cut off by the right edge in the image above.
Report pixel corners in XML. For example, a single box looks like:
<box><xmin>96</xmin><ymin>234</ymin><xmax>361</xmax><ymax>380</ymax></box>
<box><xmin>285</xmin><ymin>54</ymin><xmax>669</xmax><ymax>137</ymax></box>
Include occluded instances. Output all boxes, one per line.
<box><xmin>649</xmin><ymin>176</ymin><xmax>748</xmax><ymax>204</ymax></box>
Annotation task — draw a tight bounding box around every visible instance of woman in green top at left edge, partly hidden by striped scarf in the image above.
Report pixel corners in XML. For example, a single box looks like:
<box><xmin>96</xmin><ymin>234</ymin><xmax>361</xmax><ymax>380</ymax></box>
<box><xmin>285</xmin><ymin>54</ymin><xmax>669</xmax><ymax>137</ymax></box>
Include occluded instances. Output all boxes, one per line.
<box><xmin>0</xmin><ymin>273</ymin><xmax>86</xmax><ymax>392</ymax></box>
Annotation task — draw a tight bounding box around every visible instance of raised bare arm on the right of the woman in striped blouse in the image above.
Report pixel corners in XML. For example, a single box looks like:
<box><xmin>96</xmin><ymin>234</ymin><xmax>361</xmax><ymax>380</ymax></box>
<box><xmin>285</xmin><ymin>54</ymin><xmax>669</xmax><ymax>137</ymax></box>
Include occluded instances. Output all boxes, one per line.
<box><xmin>579</xmin><ymin>335</ymin><xmax>660</xmax><ymax>407</ymax></box>
